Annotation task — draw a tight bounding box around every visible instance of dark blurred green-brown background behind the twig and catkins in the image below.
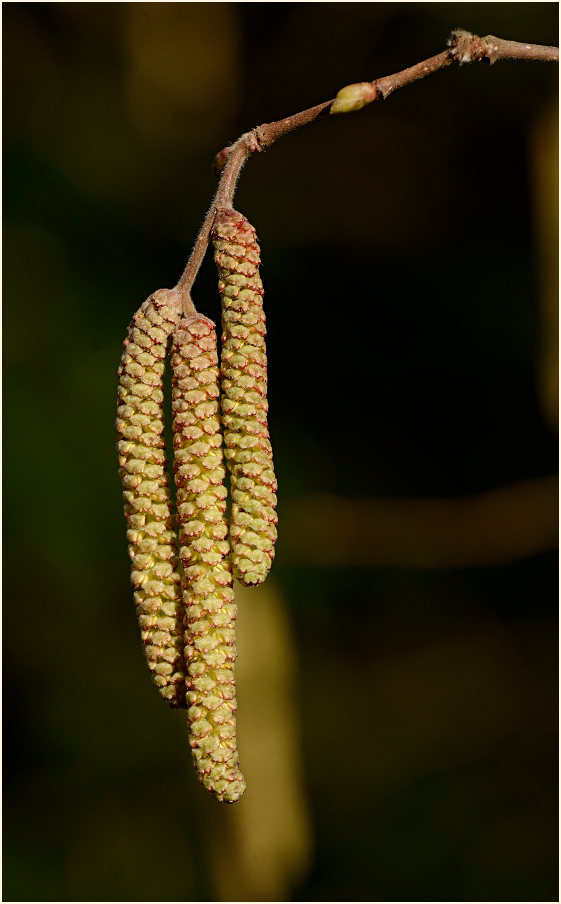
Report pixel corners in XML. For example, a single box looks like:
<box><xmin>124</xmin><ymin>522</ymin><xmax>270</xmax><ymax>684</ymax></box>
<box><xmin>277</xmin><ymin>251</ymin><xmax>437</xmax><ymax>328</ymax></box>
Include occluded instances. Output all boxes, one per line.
<box><xmin>3</xmin><ymin>3</ymin><xmax>558</xmax><ymax>901</ymax></box>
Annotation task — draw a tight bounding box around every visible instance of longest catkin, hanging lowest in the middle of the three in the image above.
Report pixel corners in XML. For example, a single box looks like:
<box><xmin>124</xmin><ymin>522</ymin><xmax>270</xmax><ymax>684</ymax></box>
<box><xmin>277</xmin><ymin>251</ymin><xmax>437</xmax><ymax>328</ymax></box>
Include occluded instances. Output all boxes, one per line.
<box><xmin>171</xmin><ymin>314</ymin><xmax>245</xmax><ymax>803</ymax></box>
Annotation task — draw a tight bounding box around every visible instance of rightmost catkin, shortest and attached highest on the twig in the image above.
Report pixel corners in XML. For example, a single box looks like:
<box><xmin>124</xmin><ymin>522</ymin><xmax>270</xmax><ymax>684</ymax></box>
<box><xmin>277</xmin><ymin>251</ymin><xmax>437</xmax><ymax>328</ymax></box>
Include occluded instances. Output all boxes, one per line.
<box><xmin>213</xmin><ymin>209</ymin><xmax>277</xmax><ymax>586</ymax></box>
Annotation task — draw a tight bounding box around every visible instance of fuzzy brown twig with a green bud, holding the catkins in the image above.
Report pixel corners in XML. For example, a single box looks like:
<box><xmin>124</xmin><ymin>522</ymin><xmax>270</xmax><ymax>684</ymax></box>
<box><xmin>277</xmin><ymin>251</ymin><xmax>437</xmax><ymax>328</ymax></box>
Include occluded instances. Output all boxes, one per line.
<box><xmin>176</xmin><ymin>29</ymin><xmax>559</xmax><ymax>300</ymax></box>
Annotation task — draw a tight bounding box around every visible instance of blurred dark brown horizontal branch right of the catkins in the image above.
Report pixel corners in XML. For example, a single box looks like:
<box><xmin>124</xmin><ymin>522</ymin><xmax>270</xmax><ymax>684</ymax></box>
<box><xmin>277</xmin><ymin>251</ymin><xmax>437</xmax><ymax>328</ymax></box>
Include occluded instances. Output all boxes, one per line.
<box><xmin>280</xmin><ymin>475</ymin><xmax>559</xmax><ymax>568</ymax></box>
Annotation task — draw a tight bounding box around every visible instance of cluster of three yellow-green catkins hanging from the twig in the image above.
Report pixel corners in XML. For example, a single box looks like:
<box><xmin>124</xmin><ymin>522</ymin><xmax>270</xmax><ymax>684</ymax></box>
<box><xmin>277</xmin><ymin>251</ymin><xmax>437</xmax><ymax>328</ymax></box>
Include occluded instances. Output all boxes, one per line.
<box><xmin>117</xmin><ymin>209</ymin><xmax>277</xmax><ymax>802</ymax></box>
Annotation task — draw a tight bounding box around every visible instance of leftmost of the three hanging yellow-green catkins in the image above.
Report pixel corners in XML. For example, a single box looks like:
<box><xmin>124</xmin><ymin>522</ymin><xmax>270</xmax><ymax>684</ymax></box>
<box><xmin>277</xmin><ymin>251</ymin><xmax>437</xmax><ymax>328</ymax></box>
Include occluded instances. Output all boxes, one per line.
<box><xmin>117</xmin><ymin>289</ymin><xmax>185</xmax><ymax>707</ymax></box>
